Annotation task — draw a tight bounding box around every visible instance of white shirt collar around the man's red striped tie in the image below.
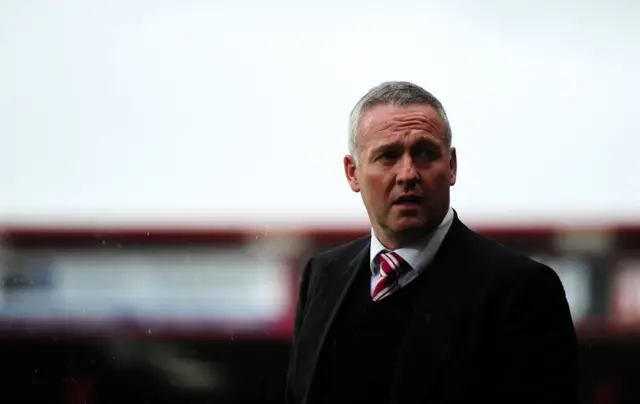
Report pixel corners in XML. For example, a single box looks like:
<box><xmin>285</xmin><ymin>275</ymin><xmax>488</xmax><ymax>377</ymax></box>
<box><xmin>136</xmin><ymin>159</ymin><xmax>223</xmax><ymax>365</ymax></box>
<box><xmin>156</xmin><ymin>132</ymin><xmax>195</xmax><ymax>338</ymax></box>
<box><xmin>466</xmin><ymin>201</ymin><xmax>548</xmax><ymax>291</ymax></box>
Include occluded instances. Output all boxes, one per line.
<box><xmin>369</xmin><ymin>207</ymin><xmax>454</xmax><ymax>293</ymax></box>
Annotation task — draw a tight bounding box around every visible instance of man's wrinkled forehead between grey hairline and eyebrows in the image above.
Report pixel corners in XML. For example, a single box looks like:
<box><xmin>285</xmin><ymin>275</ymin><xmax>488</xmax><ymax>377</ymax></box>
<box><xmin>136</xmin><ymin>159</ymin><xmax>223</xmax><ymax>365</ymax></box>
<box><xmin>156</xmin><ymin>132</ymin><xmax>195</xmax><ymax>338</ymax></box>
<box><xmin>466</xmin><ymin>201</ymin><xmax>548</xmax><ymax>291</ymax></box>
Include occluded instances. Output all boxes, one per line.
<box><xmin>357</xmin><ymin>105</ymin><xmax>445</xmax><ymax>146</ymax></box>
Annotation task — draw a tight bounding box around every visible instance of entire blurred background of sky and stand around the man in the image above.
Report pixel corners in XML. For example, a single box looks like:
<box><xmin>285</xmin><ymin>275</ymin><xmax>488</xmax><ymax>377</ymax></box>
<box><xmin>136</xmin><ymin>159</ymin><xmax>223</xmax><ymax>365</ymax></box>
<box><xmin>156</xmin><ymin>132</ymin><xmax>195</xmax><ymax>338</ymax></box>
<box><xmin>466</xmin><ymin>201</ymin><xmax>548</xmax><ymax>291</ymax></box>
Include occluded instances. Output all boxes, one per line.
<box><xmin>0</xmin><ymin>0</ymin><xmax>640</xmax><ymax>404</ymax></box>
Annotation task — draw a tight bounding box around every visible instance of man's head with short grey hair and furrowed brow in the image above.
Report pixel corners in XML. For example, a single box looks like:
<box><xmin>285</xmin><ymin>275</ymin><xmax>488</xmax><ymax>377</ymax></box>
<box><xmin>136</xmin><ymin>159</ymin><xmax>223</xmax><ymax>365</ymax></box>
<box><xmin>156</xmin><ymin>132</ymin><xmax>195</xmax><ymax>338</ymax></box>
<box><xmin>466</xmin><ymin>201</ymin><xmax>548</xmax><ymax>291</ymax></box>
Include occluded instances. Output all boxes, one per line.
<box><xmin>344</xmin><ymin>82</ymin><xmax>457</xmax><ymax>249</ymax></box>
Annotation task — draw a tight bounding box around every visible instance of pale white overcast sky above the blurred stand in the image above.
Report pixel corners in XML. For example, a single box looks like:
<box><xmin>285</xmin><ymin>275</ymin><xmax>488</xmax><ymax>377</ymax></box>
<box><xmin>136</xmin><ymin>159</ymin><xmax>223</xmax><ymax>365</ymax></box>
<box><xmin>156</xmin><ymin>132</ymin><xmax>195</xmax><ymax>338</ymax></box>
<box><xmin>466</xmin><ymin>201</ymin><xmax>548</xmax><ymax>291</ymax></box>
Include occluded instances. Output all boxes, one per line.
<box><xmin>0</xmin><ymin>0</ymin><xmax>640</xmax><ymax>226</ymax></box>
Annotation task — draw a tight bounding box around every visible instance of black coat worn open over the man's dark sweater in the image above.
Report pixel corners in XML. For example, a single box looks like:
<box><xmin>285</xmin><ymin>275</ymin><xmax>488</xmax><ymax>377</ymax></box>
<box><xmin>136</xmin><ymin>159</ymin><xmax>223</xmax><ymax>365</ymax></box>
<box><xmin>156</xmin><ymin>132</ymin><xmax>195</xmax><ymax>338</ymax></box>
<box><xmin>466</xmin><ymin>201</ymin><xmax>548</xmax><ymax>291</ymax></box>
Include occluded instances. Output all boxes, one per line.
<box><xmin>286</xmin><ymin>214</ymin><xmax>578</xmax><ymax>404</ymax></box>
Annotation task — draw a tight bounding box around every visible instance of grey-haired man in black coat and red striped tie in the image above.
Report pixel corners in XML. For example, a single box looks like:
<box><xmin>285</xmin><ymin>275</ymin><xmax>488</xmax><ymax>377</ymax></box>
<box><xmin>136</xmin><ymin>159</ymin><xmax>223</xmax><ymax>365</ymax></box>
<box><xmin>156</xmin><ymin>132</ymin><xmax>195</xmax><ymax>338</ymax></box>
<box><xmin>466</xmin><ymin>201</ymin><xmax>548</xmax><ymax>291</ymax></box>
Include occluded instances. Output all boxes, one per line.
<box><xmin>286</xmin><ymin>82</ymin><xmax>577</xmax><ymax>404</ymax></box>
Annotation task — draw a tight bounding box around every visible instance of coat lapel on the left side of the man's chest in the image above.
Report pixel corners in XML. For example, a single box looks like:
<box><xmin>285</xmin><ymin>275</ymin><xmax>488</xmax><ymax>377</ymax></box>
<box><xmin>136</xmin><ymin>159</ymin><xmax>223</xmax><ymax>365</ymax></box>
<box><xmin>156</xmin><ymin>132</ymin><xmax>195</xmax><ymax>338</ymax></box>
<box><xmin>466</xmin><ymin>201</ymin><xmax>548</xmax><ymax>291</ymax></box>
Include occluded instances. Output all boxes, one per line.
<box><xmin>303</xmin><ymin>241</ymin><xmax>371</xmax><ymax>402</ymax></box>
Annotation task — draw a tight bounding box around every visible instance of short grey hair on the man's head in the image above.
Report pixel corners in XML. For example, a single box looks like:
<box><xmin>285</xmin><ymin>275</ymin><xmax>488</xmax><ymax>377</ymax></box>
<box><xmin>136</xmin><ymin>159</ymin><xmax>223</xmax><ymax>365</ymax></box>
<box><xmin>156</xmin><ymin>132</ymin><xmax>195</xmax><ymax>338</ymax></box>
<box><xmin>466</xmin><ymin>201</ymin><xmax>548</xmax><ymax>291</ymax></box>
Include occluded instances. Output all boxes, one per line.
<box><xmin>349</xmin><ymin>81</ymin><xmax>453</xmax><ymax>164</ymax></box>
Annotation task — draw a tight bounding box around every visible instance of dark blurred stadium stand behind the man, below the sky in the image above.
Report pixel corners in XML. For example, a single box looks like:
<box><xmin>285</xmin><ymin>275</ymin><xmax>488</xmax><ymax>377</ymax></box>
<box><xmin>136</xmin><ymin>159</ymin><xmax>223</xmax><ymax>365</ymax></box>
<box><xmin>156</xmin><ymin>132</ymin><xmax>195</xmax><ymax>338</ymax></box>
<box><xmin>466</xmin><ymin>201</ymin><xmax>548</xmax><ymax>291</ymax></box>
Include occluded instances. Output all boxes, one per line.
<box><xmin>0</xmin><ymin>227</ymin><xmax>640</xmax><ymax>404</ymax></box>
